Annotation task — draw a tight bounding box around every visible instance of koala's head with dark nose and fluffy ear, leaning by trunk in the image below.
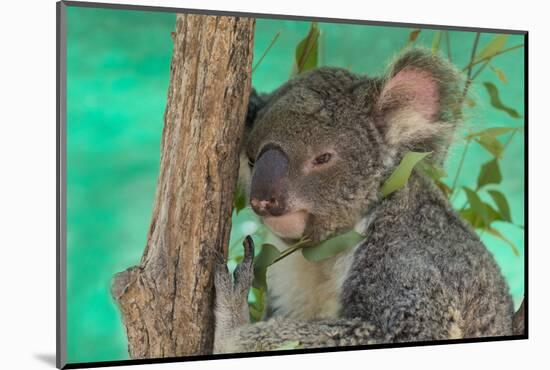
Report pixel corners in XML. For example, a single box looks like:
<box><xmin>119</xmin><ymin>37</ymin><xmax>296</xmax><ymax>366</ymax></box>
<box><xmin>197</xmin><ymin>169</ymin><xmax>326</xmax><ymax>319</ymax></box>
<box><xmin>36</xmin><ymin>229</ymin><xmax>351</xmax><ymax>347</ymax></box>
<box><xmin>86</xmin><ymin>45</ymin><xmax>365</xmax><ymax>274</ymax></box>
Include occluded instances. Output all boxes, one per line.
<box><xmin>243</xmin><ymin>49</ymin><xmax>461</xmax><ymax>242</ymax></box>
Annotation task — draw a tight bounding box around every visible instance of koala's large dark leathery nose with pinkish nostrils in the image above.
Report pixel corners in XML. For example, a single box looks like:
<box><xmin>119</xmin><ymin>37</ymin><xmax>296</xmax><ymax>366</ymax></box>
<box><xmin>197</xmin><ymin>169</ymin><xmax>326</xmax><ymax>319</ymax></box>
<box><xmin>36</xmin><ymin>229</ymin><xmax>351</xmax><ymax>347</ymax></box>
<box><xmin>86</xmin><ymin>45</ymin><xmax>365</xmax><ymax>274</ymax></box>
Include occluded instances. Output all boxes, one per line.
<box><xmin>250</xmin><ymin>147</ymin><xmax>288</xmax><ymax>216</ymax></box>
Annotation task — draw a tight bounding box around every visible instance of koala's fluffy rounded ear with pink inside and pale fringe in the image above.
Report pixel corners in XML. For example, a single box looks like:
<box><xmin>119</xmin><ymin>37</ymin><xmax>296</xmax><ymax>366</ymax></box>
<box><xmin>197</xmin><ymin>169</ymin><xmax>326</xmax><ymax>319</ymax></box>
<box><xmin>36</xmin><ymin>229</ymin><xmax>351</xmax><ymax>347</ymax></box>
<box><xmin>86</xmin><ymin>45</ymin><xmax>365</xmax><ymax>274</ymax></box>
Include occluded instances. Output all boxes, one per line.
<box><xmin>375</xmin><ymin>49</ymin><xmax>461</xmax><ymax>150</ymax></box>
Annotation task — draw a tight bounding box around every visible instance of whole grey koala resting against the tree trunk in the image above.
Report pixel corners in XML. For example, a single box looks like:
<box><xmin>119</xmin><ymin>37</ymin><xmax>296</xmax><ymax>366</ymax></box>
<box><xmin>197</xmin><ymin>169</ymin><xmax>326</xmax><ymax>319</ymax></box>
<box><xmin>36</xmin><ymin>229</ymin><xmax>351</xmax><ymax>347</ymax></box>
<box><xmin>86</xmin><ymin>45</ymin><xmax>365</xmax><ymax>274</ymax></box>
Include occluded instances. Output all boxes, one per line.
<box><xmin>214</xmin><ymin>49</ymin><xmax>514</xmax><ymax>353</ymax></box>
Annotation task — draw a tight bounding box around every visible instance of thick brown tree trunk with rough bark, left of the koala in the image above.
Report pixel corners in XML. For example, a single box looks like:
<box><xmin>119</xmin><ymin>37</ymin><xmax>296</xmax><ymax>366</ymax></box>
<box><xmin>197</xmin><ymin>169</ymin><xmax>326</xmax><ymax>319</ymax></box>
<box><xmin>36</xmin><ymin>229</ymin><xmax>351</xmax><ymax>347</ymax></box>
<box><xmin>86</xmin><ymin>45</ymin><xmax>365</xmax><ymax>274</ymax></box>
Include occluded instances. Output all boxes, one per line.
<box><xmin>112</xmin><ymin>15</ymin><xmax>254</xmax><ymax>358</ymax></box>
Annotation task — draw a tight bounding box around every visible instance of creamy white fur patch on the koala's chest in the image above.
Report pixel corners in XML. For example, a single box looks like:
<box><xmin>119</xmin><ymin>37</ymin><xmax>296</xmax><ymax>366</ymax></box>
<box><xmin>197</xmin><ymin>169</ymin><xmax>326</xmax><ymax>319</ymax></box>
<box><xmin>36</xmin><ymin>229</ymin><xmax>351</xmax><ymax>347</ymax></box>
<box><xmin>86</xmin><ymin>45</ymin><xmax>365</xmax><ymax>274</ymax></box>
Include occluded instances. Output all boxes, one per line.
<box><xmin>267</xmin><ymin>247</ymin><xmax>355</xmax><ymax>320</ymax></box>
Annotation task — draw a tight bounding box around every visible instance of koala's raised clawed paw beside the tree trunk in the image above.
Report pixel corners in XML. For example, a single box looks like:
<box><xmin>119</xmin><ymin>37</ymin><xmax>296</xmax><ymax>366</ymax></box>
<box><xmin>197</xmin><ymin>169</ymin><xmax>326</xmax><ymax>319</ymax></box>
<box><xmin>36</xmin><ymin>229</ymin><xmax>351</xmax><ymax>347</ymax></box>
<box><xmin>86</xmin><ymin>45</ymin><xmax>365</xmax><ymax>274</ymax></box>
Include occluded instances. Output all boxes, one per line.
<box><xmin>214</xmin><ymin>236</ymin><xmax>254</xmax><ymax>327</ymax></box>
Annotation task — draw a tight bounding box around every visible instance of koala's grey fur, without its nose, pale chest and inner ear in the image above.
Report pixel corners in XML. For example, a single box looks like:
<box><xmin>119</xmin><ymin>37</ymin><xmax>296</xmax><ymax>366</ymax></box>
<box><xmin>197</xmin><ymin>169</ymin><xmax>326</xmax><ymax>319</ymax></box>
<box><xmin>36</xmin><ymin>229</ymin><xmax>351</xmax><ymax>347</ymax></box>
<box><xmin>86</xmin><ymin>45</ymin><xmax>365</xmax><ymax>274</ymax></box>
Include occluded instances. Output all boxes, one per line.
<box><xmin>216</xmin><ymin>49</ymin><xmax>513</xmax><ymax>352</ymax></box>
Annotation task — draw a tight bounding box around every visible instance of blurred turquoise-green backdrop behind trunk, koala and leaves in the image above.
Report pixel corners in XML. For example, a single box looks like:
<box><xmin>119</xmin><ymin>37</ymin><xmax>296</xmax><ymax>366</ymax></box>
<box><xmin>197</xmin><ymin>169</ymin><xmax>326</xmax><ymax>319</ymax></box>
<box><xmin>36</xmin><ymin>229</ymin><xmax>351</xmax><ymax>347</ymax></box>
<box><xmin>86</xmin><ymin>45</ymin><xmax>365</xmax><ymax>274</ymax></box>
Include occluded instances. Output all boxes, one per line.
<box><xmin>67</xmin><ymin>6</ymin><xmax>524</xmax><ymax>363</ymax></box>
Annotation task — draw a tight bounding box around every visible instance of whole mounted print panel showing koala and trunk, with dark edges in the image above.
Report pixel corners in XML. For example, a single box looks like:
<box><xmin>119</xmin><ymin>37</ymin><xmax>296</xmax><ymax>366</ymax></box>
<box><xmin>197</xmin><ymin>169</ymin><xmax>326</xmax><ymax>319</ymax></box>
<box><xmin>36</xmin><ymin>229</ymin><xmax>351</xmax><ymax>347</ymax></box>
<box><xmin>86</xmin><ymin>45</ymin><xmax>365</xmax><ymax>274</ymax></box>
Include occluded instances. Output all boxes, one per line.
<box><xmin>57</xmin><ymin>1</ymin><xmax>527</xmax><ymax>368</ymax></box>
